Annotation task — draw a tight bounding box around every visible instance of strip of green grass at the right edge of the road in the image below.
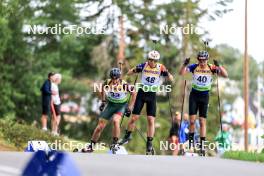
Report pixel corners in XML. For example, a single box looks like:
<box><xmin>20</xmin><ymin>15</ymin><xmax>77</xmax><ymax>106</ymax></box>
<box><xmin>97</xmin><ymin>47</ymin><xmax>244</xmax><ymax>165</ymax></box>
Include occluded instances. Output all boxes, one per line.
<box><xmin>223</xmin><ymin>151</ymin><xmax>264</xmax><ymax>163</ymax></box>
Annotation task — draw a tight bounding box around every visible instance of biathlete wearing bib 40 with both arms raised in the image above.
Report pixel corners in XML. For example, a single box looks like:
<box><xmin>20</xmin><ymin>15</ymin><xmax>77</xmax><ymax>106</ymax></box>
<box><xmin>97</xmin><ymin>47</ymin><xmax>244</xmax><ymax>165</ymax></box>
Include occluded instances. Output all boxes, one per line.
<box><xmin>180</xmin><ymin>51</ymin><xmax>228</xmax><ymax>156</ymax></box>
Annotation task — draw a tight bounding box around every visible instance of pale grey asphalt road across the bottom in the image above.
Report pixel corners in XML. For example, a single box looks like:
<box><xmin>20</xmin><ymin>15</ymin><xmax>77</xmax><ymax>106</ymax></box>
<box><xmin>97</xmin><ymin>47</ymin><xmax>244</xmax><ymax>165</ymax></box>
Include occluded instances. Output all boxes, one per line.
<box><xmin>0</xmin><ymin>152</ymin><xmax>264</xmax><ymax>176</ymax></box>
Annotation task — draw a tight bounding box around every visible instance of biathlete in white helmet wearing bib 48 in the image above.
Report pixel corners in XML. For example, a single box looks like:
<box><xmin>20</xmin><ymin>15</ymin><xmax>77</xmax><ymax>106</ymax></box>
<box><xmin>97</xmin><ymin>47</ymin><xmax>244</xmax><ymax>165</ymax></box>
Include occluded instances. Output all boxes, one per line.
<box><xmin>120</xmin><ymin>50</ymin><xmax>173</xmax><ymax>155</ymax></box>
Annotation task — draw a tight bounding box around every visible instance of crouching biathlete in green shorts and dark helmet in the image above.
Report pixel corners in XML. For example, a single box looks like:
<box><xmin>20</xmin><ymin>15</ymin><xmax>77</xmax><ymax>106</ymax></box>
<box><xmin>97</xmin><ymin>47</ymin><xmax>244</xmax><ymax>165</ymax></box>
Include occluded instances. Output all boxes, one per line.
<box><xmin>82</xmin><ymin>68</ymin><xmax>136</xmax><ymax>153</ymax></box>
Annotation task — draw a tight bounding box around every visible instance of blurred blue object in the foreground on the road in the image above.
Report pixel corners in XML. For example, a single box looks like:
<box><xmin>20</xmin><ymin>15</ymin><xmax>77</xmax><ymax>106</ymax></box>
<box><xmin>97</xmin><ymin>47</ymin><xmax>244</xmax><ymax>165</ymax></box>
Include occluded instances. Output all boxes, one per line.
<box><xmin>22</xmin><ymin>150</ymin><xmax>81</xmax><ymax>176</ymax></box>
